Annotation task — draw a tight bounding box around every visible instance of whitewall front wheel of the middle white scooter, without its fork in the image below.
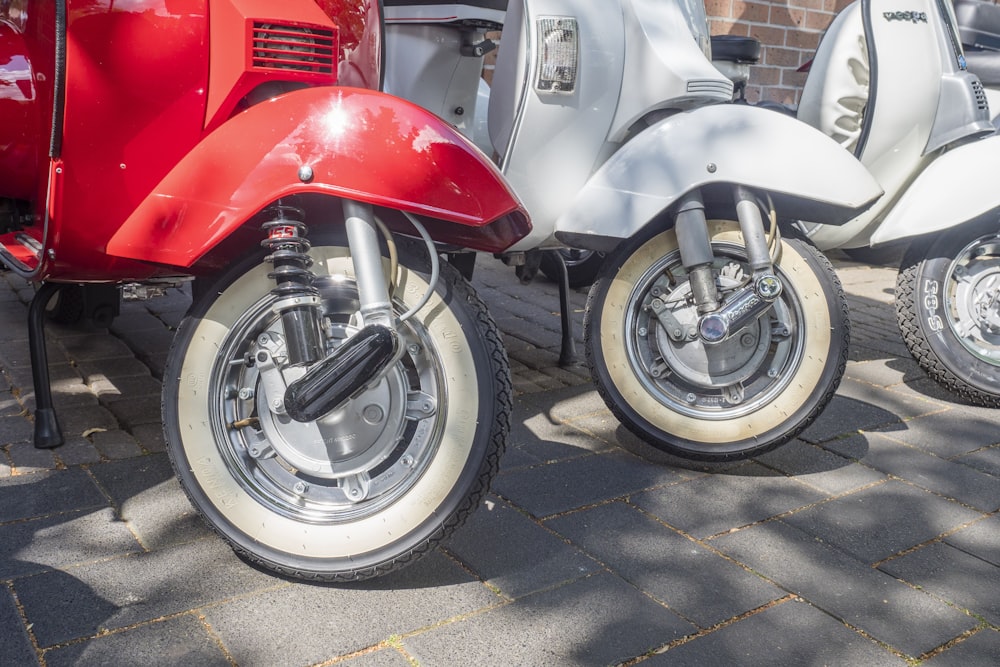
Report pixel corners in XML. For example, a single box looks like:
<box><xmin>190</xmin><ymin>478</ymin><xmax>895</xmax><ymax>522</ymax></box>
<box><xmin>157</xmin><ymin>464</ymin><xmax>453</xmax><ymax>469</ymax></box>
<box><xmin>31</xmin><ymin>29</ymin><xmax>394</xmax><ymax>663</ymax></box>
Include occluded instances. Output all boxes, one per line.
<box><xmin>585</xmin><ymin>221</ymin><xmax>850</xmax><ymax>461</ymax></box>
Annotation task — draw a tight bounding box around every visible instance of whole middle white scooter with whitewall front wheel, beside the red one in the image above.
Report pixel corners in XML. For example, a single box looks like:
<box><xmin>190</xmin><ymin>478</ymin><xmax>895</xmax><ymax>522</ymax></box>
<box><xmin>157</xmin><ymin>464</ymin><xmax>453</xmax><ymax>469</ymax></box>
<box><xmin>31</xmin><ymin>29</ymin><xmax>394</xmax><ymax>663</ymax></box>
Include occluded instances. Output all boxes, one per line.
<box><xmin>386</xmin><ymin>0</ymin><xmax>882</xmax><ymax>460</ymax></box>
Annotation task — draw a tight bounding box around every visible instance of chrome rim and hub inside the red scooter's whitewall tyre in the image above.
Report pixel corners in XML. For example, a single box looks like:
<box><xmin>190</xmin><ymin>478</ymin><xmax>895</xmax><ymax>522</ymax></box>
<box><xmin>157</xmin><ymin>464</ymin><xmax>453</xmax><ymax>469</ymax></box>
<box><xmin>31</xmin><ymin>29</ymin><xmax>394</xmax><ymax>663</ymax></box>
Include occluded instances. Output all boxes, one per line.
<box><xmin>209</xmin><ymin>276</ymin><xmax>446</xmax><ymax>523</ymax></box>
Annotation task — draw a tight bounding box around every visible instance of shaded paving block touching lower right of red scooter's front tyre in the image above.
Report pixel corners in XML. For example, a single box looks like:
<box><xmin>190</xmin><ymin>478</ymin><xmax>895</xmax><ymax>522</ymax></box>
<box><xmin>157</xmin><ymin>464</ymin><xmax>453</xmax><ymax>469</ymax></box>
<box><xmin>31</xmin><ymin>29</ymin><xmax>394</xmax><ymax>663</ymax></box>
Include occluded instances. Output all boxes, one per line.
<box><xmin>446</xmin><ymin>496</ymin><xmax>600</xmax><ymax>599</ymax></box>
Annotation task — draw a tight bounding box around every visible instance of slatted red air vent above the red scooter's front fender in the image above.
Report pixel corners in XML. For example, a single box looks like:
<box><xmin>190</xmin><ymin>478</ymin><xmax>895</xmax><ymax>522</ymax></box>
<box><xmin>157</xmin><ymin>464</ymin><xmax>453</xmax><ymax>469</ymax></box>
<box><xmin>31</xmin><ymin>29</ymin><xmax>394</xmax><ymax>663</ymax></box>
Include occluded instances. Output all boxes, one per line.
<box><xmin>251</xmin><ymin>22</ymin><xmax>337</xmax><ymax>74</ymax></box>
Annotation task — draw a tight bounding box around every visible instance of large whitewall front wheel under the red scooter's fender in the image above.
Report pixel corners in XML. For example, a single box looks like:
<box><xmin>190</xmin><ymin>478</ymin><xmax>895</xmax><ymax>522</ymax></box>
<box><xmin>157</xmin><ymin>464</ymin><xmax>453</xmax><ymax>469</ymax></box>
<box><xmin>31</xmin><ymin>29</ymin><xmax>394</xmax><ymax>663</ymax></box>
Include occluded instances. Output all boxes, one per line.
<box><xmin>163</xmin><ymin>240</ymin><xmax>512</xmax><ymax>581</ymax></box>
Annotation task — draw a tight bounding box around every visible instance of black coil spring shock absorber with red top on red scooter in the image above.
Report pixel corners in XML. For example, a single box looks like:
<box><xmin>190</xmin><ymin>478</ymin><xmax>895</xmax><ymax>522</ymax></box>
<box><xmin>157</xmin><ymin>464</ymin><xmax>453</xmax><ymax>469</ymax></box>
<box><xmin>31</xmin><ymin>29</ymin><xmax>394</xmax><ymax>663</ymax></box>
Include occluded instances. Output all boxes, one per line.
<box><xmin>261</xmin><ymin>203</ymin><xmax>323</xmax><ymax>366</ymax></box>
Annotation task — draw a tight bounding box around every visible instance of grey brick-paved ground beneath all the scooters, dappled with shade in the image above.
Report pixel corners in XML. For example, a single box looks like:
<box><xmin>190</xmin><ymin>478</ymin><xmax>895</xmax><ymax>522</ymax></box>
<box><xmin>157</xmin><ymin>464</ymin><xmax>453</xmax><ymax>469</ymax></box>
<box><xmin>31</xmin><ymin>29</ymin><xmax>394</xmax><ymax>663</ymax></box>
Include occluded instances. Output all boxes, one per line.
<box><xmin>0</xmin><ymin>252</ymin><xmax>1000</xmax><ymax>667</ymax></box>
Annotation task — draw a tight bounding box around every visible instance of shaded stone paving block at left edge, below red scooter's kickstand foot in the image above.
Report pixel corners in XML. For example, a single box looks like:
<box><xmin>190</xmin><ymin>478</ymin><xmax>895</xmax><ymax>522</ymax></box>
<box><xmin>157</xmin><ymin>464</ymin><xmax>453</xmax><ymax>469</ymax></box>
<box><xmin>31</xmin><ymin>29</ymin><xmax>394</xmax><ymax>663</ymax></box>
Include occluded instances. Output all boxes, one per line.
<box><xmin>0</xmin><ymin>468</ymin><xmax>108</xmax><ymax>522</ymax></box>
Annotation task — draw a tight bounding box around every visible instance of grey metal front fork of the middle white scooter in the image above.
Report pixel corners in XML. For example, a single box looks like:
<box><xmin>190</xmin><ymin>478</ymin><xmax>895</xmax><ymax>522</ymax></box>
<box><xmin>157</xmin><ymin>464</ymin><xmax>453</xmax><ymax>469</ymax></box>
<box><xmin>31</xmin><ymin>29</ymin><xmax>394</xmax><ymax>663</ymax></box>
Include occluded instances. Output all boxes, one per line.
<box><xmin>675</xmin><ymin>185</ymin><xmax>782</xmax><ymax>344</ymax></box>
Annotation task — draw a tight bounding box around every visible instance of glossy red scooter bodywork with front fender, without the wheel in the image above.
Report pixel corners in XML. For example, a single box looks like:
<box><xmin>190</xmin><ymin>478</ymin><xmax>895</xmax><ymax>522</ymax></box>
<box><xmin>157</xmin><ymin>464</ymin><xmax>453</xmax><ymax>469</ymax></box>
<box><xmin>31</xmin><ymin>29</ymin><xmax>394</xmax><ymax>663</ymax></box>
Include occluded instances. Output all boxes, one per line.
<box><xmin>0</xmin><ymin>0</ymin><xmax>528</xmax><ymax>282</ymax></box>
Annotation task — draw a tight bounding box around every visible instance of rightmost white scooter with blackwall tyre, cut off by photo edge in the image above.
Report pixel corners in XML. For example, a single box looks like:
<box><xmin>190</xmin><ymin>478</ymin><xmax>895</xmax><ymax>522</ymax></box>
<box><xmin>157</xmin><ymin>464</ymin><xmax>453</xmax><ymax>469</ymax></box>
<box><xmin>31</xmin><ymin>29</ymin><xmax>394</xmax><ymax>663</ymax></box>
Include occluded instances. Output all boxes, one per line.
<box><xmin>780</xmin><ymin>0</ymin><xmax>1000</xmax><ymax>406</ymax></box>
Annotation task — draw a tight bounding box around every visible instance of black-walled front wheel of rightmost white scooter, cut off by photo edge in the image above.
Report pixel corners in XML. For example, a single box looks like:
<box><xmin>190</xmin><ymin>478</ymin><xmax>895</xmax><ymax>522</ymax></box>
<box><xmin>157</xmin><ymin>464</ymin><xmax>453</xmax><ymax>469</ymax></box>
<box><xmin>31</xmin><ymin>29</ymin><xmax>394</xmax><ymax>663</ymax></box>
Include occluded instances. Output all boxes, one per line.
<box><xmin>896</xmin><ymin>221</ymin><xmax>1000</xmax><ymax>408</ymax></box>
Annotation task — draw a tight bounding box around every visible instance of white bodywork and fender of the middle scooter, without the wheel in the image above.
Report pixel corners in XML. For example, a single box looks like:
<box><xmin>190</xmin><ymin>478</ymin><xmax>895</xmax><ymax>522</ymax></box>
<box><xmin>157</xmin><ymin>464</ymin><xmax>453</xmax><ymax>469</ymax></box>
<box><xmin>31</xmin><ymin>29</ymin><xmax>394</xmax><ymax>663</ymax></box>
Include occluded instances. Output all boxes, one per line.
<box><xmin>386</xmin><ymin>0</ymin><xmax>882</xmax><ymax>251</ymax></box>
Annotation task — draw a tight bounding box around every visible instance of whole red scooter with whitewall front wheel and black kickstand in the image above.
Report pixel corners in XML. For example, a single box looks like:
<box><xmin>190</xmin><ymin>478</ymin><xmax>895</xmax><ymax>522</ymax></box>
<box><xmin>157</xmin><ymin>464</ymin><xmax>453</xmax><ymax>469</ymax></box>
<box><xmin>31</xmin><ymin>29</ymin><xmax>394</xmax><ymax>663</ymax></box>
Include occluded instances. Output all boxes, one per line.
<box><xmin>0</xmin><ymin>0</ymin><xmax>530</xmax><ymax>580</ymax></box>
